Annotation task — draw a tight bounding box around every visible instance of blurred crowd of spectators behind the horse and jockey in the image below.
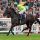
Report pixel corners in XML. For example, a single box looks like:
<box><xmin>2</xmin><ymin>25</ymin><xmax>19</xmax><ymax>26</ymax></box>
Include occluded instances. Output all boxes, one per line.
<box><xmin>0</xmin><ymin>0</ymin><xmax>40</xmax><ymax>18</ymax></box>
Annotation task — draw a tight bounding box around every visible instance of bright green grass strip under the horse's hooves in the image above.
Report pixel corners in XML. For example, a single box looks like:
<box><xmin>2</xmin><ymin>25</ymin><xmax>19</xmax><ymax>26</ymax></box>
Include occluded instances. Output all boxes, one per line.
<box><xmin>0</xmin><ymin>34</ymin><xmax>40</xmax><ymax>40</ymax></box>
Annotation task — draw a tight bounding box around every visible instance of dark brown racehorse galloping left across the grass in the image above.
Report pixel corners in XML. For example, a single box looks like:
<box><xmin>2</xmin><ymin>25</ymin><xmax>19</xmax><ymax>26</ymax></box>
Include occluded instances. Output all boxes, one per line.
<box><xmin>3</xmin><ymin>8</ymin><xmax>39</xmax><ymax>36</ymax></box>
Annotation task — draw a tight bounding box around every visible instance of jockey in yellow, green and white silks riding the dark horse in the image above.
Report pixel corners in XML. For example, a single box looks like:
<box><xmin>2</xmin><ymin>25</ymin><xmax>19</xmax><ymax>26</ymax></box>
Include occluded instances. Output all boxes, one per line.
<box><xmin>17</xmin><ymin>3</ymin><xmax>29</xmax><ymax>17</ymax></box>
